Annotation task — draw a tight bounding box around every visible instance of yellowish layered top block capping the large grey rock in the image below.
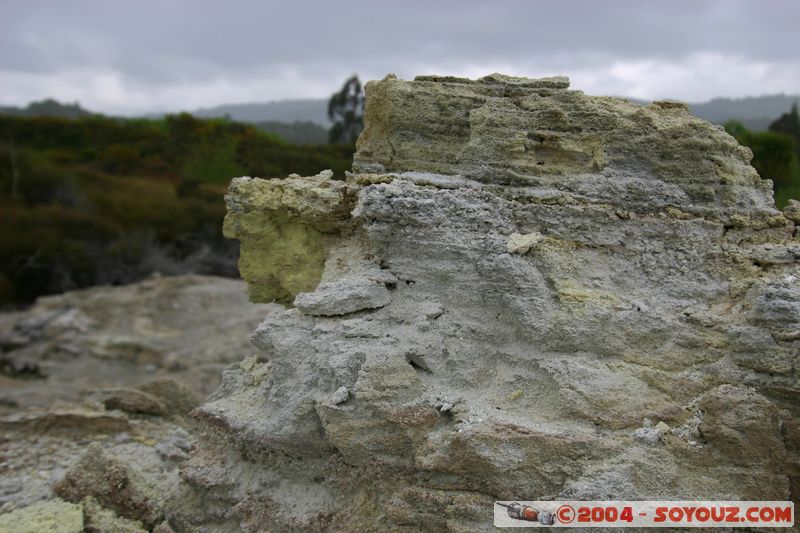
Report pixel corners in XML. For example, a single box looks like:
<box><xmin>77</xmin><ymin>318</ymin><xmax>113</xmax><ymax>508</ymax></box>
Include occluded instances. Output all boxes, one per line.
<box><xmin>354</xmin><ymin>74</ymin><xmax>771</xmax><ymax>216</ymax></box>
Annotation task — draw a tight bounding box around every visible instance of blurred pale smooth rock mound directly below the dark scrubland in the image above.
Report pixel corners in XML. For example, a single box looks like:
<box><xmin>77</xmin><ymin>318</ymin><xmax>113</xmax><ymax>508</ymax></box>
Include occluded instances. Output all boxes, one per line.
<box><xmin>0</xmin><ymin>276</ymin><xmax>270</xmax><ymax>414</ymax></box>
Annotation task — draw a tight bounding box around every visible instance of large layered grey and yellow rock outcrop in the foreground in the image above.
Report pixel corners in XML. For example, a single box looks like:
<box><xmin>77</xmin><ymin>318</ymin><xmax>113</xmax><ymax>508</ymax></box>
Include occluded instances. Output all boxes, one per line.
<box><xmin>189</xmin><ymin>75</ymin><xmax>800</xmax><ymax>531</ymax></box>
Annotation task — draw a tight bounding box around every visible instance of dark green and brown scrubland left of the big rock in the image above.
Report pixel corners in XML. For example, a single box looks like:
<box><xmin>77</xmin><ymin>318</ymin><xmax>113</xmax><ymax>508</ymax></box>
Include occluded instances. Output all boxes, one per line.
<box><xmin>0</xmin><ymin>114</ymin><xmax>353</xmax><ymax>306</ymax></box>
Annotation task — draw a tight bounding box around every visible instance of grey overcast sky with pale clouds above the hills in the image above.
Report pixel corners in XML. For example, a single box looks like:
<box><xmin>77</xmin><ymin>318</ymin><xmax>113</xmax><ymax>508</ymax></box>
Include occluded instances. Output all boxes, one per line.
<box><xmin>0</xmin><ymin>0</ymin><xmax>800</xmax><ymax>114</ymax></box>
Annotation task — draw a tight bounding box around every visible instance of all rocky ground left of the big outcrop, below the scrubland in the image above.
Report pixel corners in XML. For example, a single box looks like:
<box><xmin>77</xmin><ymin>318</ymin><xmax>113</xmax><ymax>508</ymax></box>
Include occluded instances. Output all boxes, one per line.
<box><xmin>0</xmin><ymin>276</ymin><xmax>274</xmax><ymax>532</ymax></box>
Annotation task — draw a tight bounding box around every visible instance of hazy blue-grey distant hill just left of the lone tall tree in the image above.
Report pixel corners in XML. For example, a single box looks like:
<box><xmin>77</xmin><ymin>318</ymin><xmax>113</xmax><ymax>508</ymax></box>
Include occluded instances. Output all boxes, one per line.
<box><xmin>190</xmin><ymin>98</ymin><xmax>331</xmax><ymax>125</ymax></box>
